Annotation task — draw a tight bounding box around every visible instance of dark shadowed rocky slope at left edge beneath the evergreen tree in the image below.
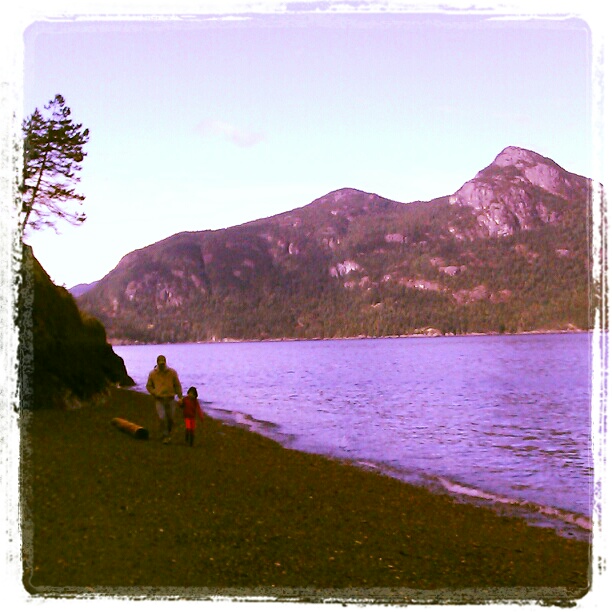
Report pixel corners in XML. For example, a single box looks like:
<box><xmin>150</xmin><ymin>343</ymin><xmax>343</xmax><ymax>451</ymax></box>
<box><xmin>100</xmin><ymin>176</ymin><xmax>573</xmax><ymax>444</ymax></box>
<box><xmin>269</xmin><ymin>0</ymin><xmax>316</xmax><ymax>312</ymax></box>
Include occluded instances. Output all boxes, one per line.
<box><xmin>17</xmin><ymin>246</ymin><xmax>134</xmax><ymax>409</ymax></box>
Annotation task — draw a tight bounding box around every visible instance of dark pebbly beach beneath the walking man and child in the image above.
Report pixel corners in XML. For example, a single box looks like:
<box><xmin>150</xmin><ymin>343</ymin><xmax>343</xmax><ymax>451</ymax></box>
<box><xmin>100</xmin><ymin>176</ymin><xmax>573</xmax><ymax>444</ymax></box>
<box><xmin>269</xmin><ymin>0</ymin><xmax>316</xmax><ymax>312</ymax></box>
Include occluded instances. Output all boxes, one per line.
<box><xmin>21</xmin><ymin>390</ymin><xmax>591</xmax><ymax>603</ymax></box>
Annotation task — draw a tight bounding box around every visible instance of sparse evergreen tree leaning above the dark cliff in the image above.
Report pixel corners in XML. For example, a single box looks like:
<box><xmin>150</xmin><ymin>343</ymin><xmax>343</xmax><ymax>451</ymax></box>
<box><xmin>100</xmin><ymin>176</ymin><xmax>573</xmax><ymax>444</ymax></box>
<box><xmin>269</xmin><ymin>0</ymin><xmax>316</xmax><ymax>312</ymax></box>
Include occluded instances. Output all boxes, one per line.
<box><xmin>20</xmin><ymin>94</ymin><xmax>89</xmax><ymax>236</ymax></box>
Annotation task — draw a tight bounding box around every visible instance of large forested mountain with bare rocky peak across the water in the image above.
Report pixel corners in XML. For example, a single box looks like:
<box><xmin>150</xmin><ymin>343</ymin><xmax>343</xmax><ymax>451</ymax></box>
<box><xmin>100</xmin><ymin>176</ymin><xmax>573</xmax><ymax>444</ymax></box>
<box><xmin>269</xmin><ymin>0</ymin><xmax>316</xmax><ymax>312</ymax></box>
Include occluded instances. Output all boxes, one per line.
<box><xmin>78</xmin><ymin>147</ymin><xmax>591</xmax><ymax>343</ymax></box>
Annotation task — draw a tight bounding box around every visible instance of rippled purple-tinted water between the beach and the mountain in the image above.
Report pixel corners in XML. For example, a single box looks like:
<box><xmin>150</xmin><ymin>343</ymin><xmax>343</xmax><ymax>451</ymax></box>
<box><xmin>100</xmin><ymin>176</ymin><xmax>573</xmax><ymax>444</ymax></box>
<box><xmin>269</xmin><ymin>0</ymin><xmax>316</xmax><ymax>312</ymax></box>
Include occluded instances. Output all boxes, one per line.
<box><xmin>115</xmin><ymin>334</ymin><xmax>593</xmax><ymax>538</ymax></box>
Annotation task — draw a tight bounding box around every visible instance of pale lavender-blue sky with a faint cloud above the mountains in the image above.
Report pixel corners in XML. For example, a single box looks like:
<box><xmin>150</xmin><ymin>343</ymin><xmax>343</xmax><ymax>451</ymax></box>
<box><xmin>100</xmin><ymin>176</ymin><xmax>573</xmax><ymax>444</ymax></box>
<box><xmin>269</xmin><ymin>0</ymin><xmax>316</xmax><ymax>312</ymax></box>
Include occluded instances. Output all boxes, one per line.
<box><xmin>15</xmin><ymin>2</ymin><xmax>594</xmax><ymax>288</ymax></box>
